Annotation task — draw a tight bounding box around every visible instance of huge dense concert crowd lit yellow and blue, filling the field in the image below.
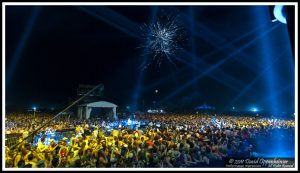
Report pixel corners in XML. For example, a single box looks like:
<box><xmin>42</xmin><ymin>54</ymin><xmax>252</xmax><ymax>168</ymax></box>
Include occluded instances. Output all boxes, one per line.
<box><xmin>5</xmin><ymin>114</ymin><xmax>295</xmax><ymax>168</ymax></box>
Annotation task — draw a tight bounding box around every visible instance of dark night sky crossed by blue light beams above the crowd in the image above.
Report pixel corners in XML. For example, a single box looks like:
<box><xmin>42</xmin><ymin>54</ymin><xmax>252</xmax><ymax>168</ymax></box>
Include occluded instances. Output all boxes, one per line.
<box><xmin>5</xmin><ymin>6</ymin><xmax>295</xmax><ymax>112</ymax></box>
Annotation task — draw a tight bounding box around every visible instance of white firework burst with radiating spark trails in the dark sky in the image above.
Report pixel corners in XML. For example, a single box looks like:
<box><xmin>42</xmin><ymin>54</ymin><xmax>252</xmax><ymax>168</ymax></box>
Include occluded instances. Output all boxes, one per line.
<box><xmin>140</xmin><ymin>15</ymin><xmax>186</xmax><ymax>69</ymax></box>
